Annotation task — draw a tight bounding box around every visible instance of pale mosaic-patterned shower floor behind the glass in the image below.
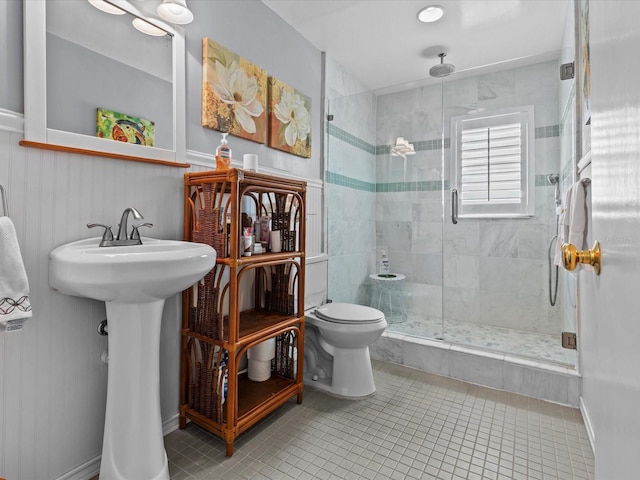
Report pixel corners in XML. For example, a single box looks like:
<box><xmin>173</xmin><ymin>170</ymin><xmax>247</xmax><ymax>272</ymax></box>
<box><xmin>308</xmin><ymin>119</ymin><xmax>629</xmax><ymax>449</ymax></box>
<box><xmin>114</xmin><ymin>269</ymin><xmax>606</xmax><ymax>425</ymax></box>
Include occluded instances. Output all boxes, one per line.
<box><xmin>387</xmin><ymin>314</ymin><xmax>575</xmax><ymax>366</ymax></box>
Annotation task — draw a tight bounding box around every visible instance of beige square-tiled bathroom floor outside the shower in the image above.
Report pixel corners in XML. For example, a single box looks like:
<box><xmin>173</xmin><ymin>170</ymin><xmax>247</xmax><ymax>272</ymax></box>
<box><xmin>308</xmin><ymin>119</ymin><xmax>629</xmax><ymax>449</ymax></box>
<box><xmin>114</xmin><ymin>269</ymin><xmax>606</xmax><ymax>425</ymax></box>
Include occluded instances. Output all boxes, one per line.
<box><xmin>165</xmin><ymin>361</ymin><xmax>595</xmax><ymax>480</ymax></box>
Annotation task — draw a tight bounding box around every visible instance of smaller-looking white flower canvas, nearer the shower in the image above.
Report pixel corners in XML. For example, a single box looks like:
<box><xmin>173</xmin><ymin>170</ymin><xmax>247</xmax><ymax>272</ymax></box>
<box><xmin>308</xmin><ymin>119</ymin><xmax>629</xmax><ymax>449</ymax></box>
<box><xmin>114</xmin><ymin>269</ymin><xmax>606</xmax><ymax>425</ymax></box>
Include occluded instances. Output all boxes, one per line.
<box><xmin>269</xmin><ymin>77</ymin><xmax>311</xmax><ymax>158</ymax></box>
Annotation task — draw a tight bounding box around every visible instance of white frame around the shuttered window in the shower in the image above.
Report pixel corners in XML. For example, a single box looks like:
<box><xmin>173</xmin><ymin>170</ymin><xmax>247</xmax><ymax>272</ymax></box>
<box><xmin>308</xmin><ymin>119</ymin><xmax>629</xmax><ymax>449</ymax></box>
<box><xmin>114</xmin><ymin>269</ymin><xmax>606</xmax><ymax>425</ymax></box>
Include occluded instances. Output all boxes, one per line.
<box><xmin>451</xmin><ymin>105</ymin><xmax>535</xmax><ymax>218</ymax></box>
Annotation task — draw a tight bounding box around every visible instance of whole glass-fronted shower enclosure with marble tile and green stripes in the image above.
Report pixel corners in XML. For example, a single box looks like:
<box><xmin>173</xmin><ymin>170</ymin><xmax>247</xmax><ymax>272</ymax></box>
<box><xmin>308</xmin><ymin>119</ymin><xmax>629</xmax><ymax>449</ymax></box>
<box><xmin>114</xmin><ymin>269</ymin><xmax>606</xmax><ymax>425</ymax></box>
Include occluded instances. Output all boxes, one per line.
<box><xmin>325</xmin><ymin>58</ymin><xmax>576</xmax><ymax>365</ymax></box>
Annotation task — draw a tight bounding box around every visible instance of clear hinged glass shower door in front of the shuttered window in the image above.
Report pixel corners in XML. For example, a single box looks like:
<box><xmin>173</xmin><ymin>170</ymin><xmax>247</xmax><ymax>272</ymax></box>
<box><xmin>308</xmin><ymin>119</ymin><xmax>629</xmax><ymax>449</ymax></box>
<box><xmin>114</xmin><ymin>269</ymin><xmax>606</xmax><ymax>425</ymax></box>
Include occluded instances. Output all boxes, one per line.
<box><xmin>442</xmin><ymin>61</ymin><xmax>573</xmax><ymax>364</ymax></box>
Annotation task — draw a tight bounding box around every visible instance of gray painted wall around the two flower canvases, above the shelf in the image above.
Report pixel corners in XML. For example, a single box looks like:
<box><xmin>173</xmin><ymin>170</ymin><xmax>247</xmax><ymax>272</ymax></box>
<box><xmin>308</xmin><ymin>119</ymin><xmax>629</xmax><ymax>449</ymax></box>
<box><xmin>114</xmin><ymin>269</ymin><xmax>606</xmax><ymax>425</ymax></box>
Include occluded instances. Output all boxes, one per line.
<box><xmin>186</xmin><ymin>0</ymin><xmax>323</xmax><ymax>179</ymax></box>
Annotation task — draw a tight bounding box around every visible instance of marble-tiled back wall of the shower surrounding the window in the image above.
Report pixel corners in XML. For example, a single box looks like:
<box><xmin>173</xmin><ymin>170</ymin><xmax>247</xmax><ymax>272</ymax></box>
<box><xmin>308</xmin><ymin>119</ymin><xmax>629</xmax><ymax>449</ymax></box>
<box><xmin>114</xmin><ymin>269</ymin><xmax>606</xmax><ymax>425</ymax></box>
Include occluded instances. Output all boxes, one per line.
<box><xmin>376</xmin><ymin>62</ymin><xmax>562</xmax><ymax>333</ymax></box>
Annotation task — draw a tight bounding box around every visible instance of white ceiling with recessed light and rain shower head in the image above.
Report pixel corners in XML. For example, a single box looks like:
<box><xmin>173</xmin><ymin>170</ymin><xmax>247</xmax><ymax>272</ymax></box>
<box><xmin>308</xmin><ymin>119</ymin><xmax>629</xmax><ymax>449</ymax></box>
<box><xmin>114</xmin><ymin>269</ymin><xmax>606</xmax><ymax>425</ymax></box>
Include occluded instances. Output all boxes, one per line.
<box><xmin>263</xmin><ymin>0</ymin><xmax>570</xmax><ymax>93</ymax></box>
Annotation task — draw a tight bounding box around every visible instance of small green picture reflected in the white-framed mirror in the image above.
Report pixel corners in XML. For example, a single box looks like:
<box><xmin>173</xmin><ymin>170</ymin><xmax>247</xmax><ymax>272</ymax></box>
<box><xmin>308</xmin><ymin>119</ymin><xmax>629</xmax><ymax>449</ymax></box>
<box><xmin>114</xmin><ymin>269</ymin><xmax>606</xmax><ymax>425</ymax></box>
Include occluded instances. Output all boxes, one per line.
<box><xmin>96</xmin><ymin>108</ymin><xmax>155</xmax><ymax>147</ymax></box>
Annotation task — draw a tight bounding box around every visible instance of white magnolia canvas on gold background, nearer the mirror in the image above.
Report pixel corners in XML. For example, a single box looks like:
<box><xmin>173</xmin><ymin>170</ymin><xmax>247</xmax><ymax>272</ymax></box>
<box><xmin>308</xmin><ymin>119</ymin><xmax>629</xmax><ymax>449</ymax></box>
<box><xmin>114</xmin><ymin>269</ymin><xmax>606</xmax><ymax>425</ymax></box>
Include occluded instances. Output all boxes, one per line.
<box><xmin>202</xmin><ymin>38</ymin><xmax>267</xmax><ymax>143</ymax></box>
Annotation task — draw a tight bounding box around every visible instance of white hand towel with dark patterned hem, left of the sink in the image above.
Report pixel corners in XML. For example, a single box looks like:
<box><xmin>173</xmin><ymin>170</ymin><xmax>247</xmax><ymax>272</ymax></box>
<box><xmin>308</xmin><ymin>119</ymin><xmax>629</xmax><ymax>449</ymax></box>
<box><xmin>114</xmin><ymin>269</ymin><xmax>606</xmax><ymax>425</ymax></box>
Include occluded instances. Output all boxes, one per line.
<box><xmin>0</xmin><ymin>217</ymin><xmax>32</xmax><ymax>324</ymax></box>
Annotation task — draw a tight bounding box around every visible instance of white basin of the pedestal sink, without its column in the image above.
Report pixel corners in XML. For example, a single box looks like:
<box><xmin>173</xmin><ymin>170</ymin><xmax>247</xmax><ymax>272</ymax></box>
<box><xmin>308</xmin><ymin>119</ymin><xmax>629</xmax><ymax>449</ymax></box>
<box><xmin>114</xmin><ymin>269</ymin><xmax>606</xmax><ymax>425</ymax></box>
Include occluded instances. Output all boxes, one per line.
<box><xmin>49</xmin><ymin>237</ymin><xmax>216</xmax><ymax>303</ymax></box>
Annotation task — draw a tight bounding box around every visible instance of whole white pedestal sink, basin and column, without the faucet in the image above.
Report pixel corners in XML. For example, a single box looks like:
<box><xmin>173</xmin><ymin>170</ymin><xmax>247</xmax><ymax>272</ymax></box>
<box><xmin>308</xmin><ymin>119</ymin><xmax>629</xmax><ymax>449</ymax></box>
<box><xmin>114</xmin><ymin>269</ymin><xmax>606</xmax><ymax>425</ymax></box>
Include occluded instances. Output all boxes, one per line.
<box><xmin>49</xmin><ymin>237</ymin><xmax>216</xmax><ymax>480</ymax></box>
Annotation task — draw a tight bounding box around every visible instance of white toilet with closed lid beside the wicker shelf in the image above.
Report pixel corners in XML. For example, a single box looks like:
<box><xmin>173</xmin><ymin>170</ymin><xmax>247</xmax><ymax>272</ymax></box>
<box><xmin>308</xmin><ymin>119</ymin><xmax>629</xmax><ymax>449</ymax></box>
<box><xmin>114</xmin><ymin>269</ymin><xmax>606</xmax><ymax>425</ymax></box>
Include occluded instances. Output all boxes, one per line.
<box><xmin>304</xmin><ymin>259</ymin><xmax>387</xmax><ymax>398</ymax></box>
